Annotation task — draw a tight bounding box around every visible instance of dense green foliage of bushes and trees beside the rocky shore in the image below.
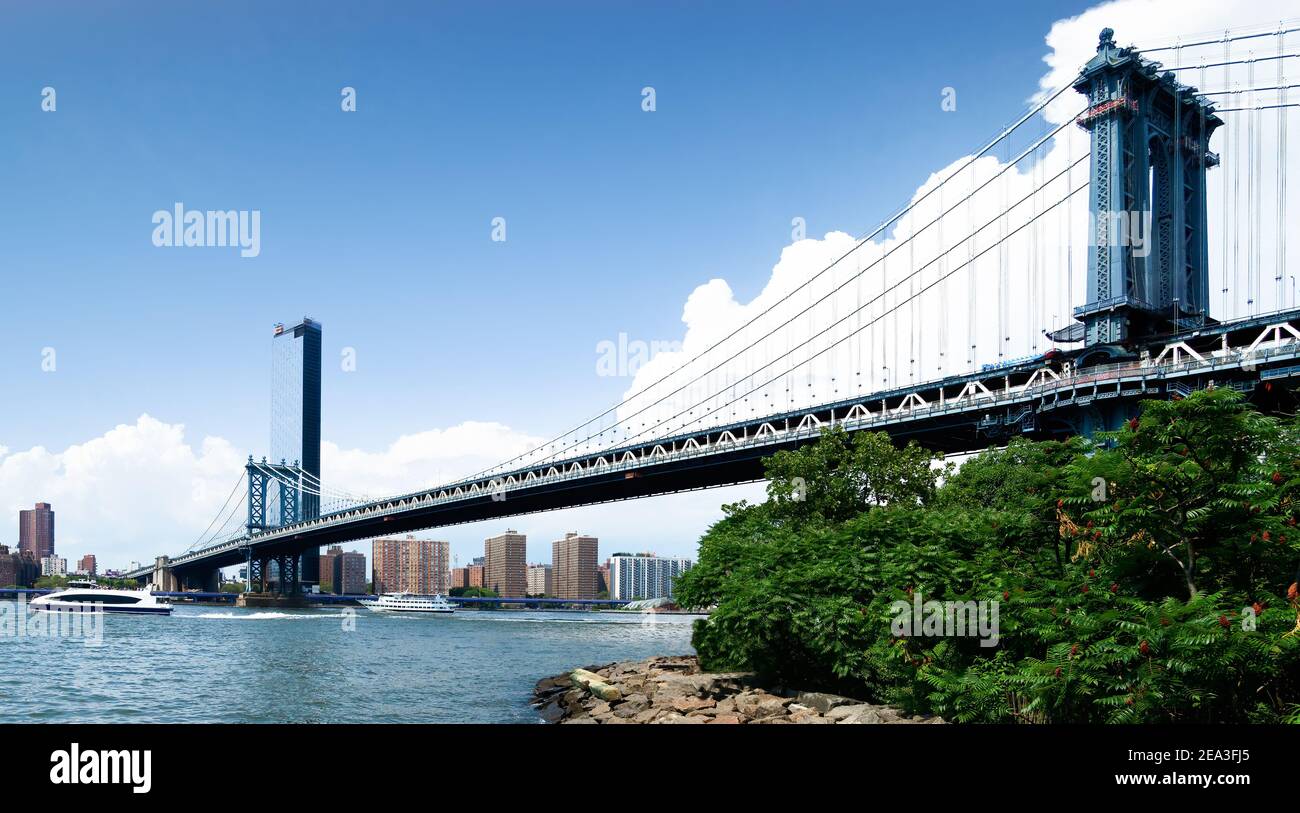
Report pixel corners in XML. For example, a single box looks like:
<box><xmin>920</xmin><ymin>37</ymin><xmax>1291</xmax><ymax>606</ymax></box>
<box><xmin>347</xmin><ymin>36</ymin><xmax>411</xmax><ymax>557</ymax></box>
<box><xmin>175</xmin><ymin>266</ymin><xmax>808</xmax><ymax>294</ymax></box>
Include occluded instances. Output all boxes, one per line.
<box><xmin>675</xmin><ymin>390</ymin><xmax>1300</xmax><ymax>723</ymax></box>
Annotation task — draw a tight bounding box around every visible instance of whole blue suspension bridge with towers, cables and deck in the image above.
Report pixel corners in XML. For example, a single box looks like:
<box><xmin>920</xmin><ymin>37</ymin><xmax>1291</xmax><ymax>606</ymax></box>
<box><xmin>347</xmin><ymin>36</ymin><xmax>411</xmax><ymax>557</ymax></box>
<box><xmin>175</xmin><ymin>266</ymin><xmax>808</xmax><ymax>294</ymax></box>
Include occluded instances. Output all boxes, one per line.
<box><xmin>127</xmin><ymin>23</ymin><xmax>1300</xmax><ymax>592</ymax></box>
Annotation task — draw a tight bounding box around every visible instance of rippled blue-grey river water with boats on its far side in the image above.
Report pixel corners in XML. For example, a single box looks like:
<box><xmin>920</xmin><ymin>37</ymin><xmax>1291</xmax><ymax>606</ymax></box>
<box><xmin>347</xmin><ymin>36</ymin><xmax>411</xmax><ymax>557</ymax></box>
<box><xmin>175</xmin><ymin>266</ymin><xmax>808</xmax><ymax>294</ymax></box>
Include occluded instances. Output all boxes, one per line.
<box><xmin>0</xmin><ymin>602</ymin><xmax>694</xmax><ymax>722</ymax></box>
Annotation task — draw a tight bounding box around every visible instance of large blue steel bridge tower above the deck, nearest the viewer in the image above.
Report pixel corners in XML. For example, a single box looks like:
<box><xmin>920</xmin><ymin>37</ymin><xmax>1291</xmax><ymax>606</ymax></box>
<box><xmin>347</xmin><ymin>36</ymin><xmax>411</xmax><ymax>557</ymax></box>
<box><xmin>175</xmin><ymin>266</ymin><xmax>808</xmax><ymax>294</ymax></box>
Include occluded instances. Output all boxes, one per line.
<box><xmin>1073</xmin><ymin>29</ymin><xmax>1223</xmax><ymax>350</ymax></box>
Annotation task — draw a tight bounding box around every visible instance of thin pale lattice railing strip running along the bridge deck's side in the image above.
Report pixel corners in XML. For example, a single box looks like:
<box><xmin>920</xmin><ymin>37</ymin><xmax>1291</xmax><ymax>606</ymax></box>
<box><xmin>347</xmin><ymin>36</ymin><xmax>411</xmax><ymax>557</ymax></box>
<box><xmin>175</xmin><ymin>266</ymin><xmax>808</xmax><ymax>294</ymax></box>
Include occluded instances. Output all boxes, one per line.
<box><xmin>131</xmin><ymin>321</ymin><xmax>1300</xmax><ymax>576</ymax></box>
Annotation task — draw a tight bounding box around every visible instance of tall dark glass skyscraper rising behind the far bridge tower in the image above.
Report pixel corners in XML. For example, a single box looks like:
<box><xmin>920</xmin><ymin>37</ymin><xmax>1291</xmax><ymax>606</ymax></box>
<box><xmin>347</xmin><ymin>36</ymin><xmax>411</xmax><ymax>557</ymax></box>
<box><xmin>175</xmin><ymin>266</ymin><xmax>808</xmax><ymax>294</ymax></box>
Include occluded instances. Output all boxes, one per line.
<box><xmin>270</xmin><ymin>316</ymin><xmax>321</xmax><ymax>585</ymax></box>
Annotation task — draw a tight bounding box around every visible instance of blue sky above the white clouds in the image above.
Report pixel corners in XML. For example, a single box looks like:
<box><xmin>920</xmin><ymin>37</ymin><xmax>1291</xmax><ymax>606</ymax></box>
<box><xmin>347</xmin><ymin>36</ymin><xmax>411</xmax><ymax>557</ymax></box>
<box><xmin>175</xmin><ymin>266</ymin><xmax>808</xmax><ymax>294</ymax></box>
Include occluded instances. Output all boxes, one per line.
<box><xmin>0</xmin><ymin>0</ymin><xmax>1102</xmax><ymax>567</ymax></box>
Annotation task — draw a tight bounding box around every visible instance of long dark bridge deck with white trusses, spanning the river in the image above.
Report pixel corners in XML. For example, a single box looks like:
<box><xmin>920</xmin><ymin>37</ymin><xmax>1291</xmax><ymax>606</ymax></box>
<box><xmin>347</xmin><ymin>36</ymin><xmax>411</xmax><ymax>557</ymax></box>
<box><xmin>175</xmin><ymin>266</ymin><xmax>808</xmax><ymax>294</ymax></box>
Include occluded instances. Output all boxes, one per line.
<box><xmin>127</xmin><ymin>311</ymin><xmax>1300</xmax><ymax>579</ymax></box>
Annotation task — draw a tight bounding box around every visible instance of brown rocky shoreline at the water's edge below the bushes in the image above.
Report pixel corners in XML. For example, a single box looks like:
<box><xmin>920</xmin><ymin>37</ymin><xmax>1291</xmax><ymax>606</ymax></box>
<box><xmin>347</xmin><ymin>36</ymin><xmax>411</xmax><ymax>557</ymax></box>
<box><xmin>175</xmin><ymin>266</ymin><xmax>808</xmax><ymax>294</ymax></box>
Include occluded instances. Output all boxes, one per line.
<box><xmin>533</xmin><ymin>656</ymin><xmax>944</xmax><ymax>725</ymax></box>
